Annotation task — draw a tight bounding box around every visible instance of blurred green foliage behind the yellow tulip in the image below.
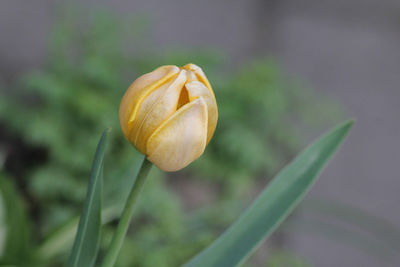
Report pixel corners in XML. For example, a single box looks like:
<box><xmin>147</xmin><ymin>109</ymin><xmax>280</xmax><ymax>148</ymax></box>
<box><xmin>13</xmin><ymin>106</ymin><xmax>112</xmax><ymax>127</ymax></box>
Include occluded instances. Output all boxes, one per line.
<box><xmin>0</xmin><ymin>8</ymin><xmax>338</xmax><ymax>267</ymax></box>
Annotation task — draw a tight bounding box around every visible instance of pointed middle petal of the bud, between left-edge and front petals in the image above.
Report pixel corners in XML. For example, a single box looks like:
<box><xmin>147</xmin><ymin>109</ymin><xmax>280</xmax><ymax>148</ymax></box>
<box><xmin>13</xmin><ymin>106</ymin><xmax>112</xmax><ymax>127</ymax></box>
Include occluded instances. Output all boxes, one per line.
<box><xmin>131</xmin><ymin>70</ymin><xmax>186</xmax><ymax>153</ymax></box>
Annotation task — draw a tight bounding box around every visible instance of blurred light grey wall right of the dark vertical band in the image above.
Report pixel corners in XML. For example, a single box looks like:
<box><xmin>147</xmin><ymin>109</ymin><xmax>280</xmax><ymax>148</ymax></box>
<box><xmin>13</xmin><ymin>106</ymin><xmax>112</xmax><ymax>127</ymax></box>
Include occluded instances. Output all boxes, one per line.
<box><xmin>270</xmin><ymin>0</ymin><xmax>400</xmax><ymax>266</ymax></box>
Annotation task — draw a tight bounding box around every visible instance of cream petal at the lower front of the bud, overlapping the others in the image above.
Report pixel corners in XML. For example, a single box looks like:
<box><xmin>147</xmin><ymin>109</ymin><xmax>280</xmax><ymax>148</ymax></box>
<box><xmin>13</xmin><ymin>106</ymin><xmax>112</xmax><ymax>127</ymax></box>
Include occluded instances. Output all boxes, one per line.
<box><xmin>147</xmin><ymin>97</ymin><xmax>208</xmax><ymax>171</ymax></box>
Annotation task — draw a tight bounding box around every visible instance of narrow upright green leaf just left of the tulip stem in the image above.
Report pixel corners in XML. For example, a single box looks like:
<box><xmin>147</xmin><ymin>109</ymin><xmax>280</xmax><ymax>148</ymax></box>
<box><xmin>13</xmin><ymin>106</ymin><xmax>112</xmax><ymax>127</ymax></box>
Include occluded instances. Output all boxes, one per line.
<box><xmin>68</xmin><ymin>129</ymin><xmax>110</xmax><ymax>267</ymax></box>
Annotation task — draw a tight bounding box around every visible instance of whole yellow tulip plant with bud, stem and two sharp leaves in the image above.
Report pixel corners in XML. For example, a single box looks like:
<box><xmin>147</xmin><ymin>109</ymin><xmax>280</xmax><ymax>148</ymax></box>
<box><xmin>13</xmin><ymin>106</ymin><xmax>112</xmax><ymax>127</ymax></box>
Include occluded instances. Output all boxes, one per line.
<box><xmin>69</xmin><ymin>64</ymin><xmax>353</xmax><ymax>267</ymax></box>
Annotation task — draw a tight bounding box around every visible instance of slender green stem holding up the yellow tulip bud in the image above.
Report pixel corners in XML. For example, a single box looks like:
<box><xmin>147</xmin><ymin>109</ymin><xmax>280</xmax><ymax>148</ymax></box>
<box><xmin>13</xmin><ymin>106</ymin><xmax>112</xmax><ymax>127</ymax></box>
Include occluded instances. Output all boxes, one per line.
<box><xmin>102</xmin><ymin>158</ymin><xmax>153</xmax><ymax>267</ymax></box>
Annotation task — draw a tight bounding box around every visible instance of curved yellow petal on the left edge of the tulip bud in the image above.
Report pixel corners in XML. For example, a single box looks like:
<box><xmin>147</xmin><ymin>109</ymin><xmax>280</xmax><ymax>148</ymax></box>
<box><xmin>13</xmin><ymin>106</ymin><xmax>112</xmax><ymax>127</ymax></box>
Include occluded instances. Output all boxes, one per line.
<box><xmin>119</xmin><ymin>66</ymin><xmax>180</xmax><ymax>137</ymax></box>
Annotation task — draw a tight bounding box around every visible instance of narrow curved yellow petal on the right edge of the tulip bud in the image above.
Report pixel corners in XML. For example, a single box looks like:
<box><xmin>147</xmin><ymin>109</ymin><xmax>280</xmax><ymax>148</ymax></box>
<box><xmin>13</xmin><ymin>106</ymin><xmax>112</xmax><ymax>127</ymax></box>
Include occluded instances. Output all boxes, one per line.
<box><xmin>185</xmin><ymin>81</ymin><xmax>218</xmax><ymax>144</ymax></box>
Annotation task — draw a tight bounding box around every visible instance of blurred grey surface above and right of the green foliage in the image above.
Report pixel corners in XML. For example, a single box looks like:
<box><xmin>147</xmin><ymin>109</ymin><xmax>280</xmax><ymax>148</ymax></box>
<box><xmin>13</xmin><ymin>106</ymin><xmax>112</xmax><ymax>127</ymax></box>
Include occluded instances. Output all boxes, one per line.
<box><xmin>0</xmin><ymin>0</ymin><xmax>400</xmax><ymax>266</ymax></box>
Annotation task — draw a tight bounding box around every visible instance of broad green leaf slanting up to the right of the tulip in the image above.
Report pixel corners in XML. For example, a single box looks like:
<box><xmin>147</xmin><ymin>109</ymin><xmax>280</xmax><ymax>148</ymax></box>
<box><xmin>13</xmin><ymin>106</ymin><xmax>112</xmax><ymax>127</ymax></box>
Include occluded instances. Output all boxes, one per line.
<box><xmin>185</xmin><ymin>121</ymin><xmax>353</xmax><ymax>267</ymax></box>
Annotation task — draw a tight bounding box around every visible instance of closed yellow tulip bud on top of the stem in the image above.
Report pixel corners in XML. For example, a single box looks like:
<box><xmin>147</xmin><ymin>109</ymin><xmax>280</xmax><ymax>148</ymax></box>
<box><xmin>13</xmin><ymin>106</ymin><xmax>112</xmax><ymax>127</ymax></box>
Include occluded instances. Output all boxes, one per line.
<box><xmin>119</xmin><ymin>64</ymin><xmax>218</xmax><ymax>171</ymax></box>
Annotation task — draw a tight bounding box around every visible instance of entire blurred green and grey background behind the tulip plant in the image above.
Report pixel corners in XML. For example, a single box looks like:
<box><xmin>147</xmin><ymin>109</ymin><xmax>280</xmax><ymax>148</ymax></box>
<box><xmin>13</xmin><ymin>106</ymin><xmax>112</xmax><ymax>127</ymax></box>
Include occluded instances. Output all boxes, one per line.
<box><xmin>0</xmin><ymin>0</ymin><xmax>400</xmax><ymax>266</ymax></box>
